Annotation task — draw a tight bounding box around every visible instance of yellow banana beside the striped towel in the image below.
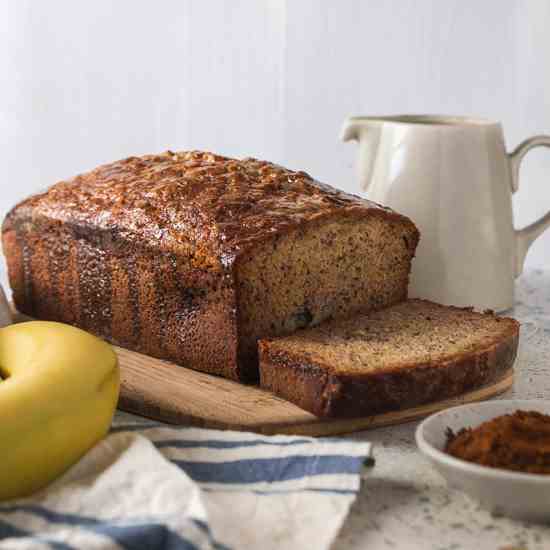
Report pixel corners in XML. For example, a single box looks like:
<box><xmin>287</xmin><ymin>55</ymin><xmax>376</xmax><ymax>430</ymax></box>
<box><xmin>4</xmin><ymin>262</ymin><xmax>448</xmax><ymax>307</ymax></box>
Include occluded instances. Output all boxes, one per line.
<box><xmin>0</xmin><ymin>321</ymin><xmax>120</xmax><ymax>500</ymax></box>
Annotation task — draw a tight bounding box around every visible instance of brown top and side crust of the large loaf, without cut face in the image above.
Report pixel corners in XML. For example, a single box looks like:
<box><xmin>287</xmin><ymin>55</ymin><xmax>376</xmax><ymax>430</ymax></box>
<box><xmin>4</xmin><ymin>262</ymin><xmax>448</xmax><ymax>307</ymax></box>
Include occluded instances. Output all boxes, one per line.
<box><xmin>2</xmin><ymin>151</ymin><xmax>418</xmax><ymax>381</ymax></box>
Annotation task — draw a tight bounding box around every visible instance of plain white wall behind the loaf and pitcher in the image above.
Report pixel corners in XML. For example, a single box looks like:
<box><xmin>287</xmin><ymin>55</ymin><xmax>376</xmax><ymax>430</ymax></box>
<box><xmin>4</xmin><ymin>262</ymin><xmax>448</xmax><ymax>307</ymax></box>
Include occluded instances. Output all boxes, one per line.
<box><xmin>0</xmin><ymin>0</ymin><xmax>550</xmax><ymax>294</ymax></box>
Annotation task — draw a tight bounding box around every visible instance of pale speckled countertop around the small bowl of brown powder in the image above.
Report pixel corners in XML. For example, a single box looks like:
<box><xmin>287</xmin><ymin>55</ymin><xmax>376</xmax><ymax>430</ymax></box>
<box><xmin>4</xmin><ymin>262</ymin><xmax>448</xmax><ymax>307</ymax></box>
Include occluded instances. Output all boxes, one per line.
<box><xmin>333</xmin><ymin>270</ymin><xmax>550</xmax><ymax>550</ymax></box>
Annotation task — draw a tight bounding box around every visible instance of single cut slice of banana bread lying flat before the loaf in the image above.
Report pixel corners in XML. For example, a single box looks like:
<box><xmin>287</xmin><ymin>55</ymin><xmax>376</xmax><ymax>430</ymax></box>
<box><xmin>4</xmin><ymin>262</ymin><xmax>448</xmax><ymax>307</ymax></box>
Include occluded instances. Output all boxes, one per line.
<box><xmin>259</xmin><ymin>300</ymin><xmax>519</xmax><ymax>417</ymax></box>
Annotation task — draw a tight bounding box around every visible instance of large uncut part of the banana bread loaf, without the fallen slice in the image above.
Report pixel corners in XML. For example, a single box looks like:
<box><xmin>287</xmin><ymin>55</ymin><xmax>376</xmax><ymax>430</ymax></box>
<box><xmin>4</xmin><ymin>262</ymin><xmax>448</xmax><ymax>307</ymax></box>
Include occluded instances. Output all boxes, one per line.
<box><xmin>2</xmin><ymin>151</ymin><xmax>418</xmax><ymax>381</ymax></box>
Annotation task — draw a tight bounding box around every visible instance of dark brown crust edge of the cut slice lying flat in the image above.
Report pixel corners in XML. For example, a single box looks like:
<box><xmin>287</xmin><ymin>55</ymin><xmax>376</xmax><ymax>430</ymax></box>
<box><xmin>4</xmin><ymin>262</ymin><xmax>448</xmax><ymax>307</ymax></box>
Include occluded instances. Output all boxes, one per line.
<box><xmin>259</xmin><ymin>308</ymin><xmax>519</xmax><ymax>418</ymax></box>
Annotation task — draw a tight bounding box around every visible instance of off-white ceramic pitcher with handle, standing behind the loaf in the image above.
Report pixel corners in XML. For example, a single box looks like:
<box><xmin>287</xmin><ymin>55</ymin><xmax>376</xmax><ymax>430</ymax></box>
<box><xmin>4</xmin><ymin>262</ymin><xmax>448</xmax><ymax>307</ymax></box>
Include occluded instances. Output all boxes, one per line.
<box><xmin>342</xmin><ymin>115</ymin><xmax>550</xmax><ymax>311</ymax></box>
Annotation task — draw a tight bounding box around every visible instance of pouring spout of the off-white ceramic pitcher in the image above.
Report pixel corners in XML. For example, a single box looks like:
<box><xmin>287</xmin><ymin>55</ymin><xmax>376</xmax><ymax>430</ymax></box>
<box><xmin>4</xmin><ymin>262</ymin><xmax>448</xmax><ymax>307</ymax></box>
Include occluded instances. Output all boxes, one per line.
<box><xmin>340</xmin><ymin>117</ymin><xmax>381</xmax><ymax>191</ymax></box>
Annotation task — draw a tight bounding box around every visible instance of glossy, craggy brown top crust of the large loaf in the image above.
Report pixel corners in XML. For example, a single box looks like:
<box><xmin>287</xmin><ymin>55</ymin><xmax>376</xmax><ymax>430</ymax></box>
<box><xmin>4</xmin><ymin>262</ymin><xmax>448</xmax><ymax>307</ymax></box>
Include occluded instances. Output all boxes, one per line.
<box><xmin>3</xmin><ymin>151</ymin><xmax>414</xmax><ymax>267</ymax></box>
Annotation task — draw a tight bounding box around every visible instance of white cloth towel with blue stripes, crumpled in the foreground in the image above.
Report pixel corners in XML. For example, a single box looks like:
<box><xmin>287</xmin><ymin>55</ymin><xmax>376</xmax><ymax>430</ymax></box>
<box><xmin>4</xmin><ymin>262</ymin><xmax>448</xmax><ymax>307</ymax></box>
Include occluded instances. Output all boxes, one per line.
<box><xmin>0</xmin><ymin>420</ymin><xmax>371</xmax><ymax>550</ymax></box>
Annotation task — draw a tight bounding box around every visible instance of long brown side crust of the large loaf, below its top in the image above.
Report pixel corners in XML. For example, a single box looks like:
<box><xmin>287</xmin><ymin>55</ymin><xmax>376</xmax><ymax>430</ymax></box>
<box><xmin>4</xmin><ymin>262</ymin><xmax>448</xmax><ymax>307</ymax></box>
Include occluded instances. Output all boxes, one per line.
<box><xmin>3</xmin><ymin>221</ymin><xmax>240</xmax><ymax>379</ymax></box>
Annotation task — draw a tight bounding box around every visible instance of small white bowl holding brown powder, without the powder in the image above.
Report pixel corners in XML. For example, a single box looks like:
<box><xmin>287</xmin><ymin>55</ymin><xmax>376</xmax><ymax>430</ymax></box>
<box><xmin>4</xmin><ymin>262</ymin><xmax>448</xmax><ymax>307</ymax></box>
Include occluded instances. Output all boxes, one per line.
<box><xmin>416</xmin><ymin>399</ymin><xmax>550</xmax><ymax>523</ymax></box>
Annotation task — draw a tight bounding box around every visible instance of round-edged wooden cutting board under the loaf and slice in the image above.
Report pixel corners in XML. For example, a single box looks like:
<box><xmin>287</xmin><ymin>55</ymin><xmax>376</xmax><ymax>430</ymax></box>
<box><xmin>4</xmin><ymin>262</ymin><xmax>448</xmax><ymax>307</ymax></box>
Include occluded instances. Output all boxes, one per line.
<box><xmin>115</xmin><ymin>348</ymin><xmax>513</xmax><ymax>436</ymax></box>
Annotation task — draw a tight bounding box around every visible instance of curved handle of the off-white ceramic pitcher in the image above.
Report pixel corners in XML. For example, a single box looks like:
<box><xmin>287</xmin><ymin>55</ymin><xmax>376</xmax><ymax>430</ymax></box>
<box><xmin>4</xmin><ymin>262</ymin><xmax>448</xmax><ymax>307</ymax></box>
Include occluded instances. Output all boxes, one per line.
<box><xmin>509</xmin><ymin>136</ymin><xmax>550</xmax><ymax>277</ymax></box>
